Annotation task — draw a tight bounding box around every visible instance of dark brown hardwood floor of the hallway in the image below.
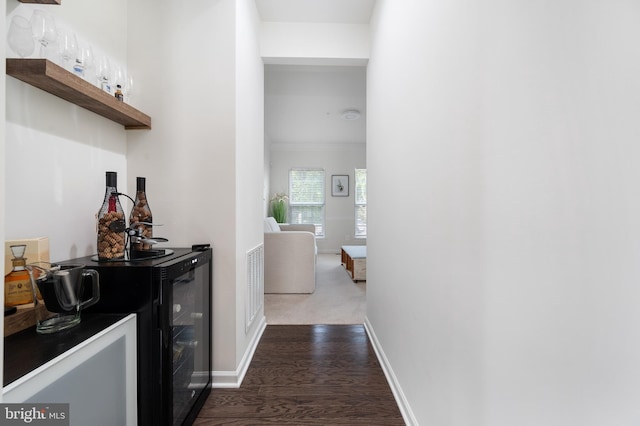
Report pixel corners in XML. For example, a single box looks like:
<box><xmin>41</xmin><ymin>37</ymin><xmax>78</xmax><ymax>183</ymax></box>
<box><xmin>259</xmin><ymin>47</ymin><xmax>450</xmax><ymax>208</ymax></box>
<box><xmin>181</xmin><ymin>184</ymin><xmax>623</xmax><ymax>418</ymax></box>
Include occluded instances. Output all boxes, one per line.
<box><xmin>194</xmin><ymin>325</ymin><xmax>404</xmax><ymax>426</ymax></box>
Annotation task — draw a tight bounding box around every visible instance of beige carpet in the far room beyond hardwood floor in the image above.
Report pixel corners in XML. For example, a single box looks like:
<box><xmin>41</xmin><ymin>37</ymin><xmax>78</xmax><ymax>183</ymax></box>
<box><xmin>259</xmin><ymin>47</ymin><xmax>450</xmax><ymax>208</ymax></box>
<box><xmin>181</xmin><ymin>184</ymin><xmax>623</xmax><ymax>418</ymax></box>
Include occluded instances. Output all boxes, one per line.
<box><xmin>264</xmin><ymin>254</ymin><xmax>366</xmax><ymax>325</ymax></box>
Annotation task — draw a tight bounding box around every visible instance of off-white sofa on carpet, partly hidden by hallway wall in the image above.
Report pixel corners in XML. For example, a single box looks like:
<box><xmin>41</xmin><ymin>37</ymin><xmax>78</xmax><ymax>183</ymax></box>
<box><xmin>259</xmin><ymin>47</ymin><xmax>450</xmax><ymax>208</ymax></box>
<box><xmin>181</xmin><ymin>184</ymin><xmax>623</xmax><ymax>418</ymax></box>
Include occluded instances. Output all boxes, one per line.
<box><xmin>264</xmin><ymin>217</ymin><xmax>318</xmax><ymax>293</ymax></box>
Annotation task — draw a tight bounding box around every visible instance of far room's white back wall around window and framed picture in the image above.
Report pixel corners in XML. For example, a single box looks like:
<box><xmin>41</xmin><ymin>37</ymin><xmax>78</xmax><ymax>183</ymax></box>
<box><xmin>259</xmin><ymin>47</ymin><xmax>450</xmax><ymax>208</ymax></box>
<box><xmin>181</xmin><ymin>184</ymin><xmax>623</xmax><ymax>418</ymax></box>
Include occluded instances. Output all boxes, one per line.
<box><xmin>270</xmin><ymin>143</ymin><xmax>367</xmax><ymax>253</ymax></box>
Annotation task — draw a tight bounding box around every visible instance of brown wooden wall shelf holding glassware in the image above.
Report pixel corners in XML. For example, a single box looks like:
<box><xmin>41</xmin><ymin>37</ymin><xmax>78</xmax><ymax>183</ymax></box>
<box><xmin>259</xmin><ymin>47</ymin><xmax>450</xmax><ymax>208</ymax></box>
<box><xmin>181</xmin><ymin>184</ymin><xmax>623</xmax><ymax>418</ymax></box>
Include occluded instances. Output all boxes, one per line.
<box><xmin>7</xmin><ymin>58</ymin><xmax>151</xmax><ymax>130</ymax></box>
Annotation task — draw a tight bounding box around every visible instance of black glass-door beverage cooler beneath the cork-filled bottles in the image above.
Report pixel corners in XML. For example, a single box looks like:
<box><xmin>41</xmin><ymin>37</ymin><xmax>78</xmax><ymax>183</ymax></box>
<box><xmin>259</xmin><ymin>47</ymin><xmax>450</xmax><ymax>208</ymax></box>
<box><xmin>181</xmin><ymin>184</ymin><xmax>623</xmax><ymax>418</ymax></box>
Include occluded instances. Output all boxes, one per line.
<box><xmin>68</xmin><ymin>245</ymin><xmax>213</xmax><ymax>426</ymax></box>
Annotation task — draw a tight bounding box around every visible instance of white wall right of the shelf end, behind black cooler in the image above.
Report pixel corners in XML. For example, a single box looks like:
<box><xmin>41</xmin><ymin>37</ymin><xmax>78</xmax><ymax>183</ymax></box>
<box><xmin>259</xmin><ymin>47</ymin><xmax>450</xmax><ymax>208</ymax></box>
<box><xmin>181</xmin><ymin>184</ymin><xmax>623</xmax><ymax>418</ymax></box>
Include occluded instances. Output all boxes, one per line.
<box><xmin>128</xmin><ymin>0</ymin><xmax>237</xmax><ymax>371</ymax></box>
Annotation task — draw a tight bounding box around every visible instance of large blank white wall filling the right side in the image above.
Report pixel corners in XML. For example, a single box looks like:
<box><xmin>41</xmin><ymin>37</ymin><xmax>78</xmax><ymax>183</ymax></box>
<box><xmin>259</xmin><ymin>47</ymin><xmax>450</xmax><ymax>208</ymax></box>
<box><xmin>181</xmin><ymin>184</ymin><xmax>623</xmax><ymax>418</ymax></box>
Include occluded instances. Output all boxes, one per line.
<box><xmin>367</xmin><ymin>0</ymin><xmax>640</xmax><ymax>426</ymax></box>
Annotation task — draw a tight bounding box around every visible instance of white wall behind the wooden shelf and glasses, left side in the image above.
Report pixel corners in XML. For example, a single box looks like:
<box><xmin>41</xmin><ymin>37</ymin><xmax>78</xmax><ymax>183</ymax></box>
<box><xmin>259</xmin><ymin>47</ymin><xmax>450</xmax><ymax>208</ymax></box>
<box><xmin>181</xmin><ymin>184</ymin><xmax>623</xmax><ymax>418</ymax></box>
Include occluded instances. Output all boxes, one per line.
<box><xmin>3</xmin><ymin>0</ymin><xmax>127</xmax><ymax>261</ymax></box>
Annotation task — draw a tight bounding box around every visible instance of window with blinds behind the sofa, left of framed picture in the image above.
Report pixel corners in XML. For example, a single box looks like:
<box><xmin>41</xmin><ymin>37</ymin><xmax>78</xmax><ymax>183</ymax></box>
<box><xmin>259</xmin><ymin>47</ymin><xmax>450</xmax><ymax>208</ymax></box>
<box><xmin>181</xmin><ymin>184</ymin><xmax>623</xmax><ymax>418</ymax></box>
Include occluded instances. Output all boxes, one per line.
<box><xmin>289</xmin><ymin>169</ymin><xmax>324</xmax><ymax>237</ymax></box>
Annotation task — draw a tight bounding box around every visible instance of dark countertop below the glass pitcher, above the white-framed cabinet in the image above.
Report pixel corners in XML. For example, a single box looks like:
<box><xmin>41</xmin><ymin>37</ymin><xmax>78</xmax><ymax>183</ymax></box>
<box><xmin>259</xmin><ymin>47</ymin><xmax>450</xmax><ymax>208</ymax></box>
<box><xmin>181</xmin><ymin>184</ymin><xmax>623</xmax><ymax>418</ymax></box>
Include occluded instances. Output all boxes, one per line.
<box><xmin>3</xmin><ymin>312</ymin><xmax>128</xmax><ymax>386</ymax></box>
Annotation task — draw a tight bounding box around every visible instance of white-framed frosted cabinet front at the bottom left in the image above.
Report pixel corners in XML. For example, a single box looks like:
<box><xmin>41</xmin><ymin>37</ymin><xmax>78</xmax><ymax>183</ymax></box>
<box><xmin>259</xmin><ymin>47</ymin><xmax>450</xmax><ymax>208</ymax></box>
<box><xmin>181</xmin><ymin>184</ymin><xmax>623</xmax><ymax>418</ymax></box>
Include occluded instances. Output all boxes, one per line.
<box><xmin>2</xmin><ymin>314</ymin><xmax>137</xmax><ymax>426</ymax></box>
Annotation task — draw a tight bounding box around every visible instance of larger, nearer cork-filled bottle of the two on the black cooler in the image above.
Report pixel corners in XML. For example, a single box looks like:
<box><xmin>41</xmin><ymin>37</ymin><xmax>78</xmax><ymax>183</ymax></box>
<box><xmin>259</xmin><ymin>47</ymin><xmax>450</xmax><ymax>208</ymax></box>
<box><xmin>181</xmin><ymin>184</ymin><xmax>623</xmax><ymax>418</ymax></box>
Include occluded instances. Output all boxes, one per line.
<box><xmin>98</xmin><ymin>172</ymin><xmax>127</xmax><ymax>260</ymax></box>
